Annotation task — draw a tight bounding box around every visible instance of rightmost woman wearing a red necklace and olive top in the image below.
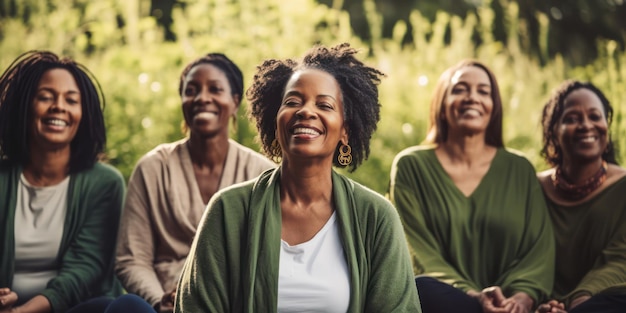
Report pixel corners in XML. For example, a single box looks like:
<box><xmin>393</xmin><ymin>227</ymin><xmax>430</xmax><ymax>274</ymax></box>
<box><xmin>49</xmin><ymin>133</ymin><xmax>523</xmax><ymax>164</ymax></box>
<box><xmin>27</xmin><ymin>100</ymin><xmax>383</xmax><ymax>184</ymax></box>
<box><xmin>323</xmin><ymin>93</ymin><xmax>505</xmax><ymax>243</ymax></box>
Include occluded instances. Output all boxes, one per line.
<box><xmin>539</xmin><ymin>81</ymin><xmax>626</xmax><ymax>313</ymax></box>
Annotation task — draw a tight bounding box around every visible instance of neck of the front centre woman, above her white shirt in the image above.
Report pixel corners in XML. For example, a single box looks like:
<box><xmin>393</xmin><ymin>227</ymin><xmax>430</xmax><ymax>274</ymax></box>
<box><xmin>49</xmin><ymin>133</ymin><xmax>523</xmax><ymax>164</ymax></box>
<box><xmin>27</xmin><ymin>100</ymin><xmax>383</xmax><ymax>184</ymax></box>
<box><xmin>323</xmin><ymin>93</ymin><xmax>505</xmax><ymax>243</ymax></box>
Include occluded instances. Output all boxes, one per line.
<box><xmin>280</xmin><ymin>161</ymin><xmax>332</xmax><ymax>207</ymax></box>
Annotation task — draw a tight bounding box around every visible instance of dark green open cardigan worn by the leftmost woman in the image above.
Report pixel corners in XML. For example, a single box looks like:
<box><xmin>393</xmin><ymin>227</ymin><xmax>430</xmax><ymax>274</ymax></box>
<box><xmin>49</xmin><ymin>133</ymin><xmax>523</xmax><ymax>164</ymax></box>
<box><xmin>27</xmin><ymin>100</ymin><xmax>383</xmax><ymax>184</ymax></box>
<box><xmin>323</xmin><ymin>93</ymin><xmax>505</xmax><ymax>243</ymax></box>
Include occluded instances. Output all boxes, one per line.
<box><xmin>0</xmin><ymin>163</ymin><xmax>125</xmax><ymax>312</ymax></box>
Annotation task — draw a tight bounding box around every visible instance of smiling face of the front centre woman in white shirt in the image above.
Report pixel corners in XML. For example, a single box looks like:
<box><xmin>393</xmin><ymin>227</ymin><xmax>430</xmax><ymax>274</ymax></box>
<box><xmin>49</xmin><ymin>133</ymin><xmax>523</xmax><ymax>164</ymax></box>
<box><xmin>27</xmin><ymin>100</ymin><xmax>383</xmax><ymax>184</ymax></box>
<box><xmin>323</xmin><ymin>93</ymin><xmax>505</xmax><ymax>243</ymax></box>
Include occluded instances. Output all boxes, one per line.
<box><xmin>276</xmin><ymin>69</ymin><xmax>348</xmax><ymax>163</ymax></box>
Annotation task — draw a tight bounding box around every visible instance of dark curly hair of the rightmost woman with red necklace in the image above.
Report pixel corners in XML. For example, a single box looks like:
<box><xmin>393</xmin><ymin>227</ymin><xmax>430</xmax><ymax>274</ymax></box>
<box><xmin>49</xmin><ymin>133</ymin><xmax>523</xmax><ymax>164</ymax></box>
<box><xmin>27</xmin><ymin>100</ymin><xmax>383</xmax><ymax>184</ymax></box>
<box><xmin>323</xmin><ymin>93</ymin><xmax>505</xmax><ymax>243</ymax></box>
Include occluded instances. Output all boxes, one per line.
<box><xmin>541</xmin><ymin>80</ymin><xmax>617</xmax><ymax>166</ymax></box>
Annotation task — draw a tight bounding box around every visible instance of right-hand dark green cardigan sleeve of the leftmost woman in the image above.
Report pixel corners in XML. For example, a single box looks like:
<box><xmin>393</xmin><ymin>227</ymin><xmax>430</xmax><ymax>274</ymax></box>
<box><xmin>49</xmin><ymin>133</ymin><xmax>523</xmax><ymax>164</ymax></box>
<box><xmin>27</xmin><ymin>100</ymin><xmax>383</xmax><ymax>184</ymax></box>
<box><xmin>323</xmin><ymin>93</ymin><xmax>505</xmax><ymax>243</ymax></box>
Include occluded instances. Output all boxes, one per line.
<box><xmin>42</xmin><ymin>170</ymin><xmax>125</xmax><ymax>312</ymax></box>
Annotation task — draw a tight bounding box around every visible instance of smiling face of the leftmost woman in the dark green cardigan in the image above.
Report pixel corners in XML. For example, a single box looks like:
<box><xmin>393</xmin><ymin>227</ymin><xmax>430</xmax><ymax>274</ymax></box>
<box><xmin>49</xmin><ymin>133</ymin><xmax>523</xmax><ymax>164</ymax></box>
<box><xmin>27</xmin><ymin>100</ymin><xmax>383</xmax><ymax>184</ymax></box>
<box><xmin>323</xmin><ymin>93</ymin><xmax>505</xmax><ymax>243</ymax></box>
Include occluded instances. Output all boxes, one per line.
<box><xmin>30</xmin><ymin>68</ymin><xmax>83</xmax><ymax>149</ymax></box>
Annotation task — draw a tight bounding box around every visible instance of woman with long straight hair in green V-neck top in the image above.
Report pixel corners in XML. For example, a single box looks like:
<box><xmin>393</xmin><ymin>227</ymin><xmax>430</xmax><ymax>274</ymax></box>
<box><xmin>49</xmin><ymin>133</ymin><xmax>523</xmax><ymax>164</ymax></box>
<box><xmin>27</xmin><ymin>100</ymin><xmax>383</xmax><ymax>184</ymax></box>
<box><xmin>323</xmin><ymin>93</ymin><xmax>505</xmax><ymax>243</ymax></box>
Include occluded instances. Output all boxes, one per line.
<box><xmin>389</xmin><ymin>60</ymin><xmax>554</xmax><ymax>312</ymax></box>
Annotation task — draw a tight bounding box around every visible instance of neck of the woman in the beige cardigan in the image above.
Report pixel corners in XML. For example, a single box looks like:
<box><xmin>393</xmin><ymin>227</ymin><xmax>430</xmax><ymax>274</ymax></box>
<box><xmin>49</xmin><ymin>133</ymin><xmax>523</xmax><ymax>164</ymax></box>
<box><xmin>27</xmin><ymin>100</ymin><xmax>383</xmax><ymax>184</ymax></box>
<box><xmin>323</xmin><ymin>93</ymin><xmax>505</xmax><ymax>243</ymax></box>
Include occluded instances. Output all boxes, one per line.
<box><xmin>187</xmin><ymin>134</ymin><xmax>229</xmax><ymax>168</ymax></box>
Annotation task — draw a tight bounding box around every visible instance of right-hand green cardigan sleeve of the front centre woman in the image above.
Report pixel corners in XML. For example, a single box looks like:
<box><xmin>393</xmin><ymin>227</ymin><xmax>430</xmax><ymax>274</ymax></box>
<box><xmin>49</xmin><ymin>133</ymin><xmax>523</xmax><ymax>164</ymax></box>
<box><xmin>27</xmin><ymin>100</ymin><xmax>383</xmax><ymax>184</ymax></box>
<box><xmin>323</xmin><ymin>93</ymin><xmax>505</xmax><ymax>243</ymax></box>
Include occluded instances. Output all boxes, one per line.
<box><xmin>365</xmin><ymin>197</ymin><xmax>422</xmax><ymax>313</ymax></box>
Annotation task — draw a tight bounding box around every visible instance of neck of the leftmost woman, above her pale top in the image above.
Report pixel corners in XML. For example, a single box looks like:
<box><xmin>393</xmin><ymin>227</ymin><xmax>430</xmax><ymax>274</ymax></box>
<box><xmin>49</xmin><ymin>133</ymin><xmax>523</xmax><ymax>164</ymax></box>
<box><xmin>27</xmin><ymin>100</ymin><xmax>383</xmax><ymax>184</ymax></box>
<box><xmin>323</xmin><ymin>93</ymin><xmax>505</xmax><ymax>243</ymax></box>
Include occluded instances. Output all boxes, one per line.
<box><xmin>23</xmin><ymin>146</ymin><xmax>70</xmax><ymax>187</ymax></box>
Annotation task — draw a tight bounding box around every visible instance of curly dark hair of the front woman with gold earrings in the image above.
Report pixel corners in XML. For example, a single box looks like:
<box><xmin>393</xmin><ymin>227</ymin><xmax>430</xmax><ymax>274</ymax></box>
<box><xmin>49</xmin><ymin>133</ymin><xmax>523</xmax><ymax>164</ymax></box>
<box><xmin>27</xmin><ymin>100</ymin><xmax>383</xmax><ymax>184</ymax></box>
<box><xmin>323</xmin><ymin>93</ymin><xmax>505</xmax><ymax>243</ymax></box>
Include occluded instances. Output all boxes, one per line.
<box><xmin>246</xmin><ymin>43</ymin><xmax>385</xmax><ymax>172</ymax></box>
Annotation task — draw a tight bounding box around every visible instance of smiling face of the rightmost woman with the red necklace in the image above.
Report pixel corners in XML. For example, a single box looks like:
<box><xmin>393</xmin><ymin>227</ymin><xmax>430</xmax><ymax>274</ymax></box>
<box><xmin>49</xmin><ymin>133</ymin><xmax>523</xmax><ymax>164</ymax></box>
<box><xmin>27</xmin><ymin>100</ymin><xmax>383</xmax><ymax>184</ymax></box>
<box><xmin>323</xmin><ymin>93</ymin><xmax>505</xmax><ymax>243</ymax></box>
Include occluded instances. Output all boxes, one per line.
<box><xmin>554</xmin><ymin>88</ymin><xmax>608</xmax><ymax>163</ymax></box>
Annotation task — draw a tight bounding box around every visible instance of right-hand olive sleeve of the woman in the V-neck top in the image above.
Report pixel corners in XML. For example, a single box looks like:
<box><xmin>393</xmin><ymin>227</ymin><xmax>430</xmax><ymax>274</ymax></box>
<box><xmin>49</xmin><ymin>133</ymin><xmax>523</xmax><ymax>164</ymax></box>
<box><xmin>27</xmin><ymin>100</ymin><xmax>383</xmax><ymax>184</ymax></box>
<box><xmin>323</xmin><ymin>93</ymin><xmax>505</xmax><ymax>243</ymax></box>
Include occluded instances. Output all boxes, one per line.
<box><xmin>501</xmin><ymin>160</ymin><xmax>555</xmax><ymax>304</ymax></box>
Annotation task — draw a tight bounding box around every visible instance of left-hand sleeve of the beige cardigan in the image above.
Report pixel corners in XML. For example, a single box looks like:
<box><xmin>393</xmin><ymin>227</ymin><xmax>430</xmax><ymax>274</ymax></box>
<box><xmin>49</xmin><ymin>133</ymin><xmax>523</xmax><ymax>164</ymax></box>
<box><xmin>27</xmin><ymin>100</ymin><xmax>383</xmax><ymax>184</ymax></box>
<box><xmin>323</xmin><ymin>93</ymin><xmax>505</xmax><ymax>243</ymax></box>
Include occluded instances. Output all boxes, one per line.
<box><xmin>115</xmin><ymin>162</ymin><xmax>165</xmax><ymax>306</ymax></box>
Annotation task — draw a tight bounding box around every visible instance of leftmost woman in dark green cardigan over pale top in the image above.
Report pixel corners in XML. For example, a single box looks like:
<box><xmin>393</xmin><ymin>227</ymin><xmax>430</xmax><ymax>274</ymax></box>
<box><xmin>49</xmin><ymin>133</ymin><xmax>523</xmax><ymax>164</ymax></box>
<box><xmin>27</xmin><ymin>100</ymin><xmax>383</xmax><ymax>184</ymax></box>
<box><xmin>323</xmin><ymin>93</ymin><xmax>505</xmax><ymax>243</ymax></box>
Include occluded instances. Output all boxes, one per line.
<box><xmin>0</xmin><ymin>51</ymin><xmax>125</xmax><ymax>313</ymax></box>
